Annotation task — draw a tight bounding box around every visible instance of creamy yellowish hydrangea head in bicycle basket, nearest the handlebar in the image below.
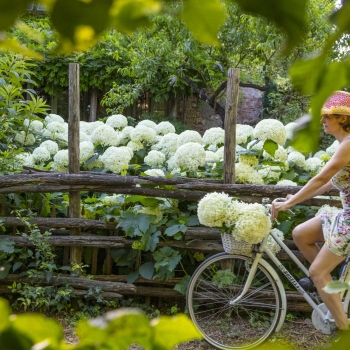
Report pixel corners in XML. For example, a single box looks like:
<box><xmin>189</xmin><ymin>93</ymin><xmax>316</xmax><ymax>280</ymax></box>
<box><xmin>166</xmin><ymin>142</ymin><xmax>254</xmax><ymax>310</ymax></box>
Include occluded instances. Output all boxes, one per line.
<box><xmin>232</xmin><ymin>203</ymin><xmax>271</xmax><ymax>244</ymax></box>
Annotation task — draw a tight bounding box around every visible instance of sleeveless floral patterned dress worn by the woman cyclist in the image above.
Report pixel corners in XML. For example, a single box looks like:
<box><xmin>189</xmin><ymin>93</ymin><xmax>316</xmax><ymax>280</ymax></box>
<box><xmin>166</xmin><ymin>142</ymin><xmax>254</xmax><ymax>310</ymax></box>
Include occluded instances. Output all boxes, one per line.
<box><xmin>321</xmin><ymin>151</ymin><xmax>350</xmax><ymax>257</ymax></box>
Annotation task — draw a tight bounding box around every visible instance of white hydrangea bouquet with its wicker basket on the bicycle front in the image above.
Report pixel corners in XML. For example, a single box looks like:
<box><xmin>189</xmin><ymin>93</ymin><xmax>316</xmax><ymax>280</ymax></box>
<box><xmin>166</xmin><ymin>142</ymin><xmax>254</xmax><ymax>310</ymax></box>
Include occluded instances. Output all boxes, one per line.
<box><xmin>198</xmin><ymin>192</ymin><xmax>271</xmax><ymax>254</ymax></box>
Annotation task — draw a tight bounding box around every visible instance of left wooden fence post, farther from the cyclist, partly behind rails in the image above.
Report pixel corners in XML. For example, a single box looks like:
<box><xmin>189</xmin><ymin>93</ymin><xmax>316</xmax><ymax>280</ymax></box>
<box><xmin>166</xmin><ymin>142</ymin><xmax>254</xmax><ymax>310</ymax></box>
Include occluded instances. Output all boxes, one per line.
<box><xmin>68</xmin><ymin>63</ymin><xmax>82</xmax><ymax>264</ymax></box>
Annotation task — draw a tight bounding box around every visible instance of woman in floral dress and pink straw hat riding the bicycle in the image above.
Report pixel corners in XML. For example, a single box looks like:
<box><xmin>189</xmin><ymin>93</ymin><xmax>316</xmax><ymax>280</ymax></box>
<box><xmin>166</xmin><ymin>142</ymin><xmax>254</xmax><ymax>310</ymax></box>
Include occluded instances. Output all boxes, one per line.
<box><xmin>271</xmin><ymin>91</ymin><xmax>350</xmax><ymax>330</ymax></box>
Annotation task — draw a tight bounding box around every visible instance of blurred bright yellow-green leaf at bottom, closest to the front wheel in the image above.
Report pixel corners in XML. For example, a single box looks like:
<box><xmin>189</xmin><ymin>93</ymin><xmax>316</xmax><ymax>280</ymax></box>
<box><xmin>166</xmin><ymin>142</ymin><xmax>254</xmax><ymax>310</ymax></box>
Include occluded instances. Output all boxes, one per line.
<box><xmin>151</xmin><ymin>314</ymin><xmax>202</xmax><ymax>350</ymax></box>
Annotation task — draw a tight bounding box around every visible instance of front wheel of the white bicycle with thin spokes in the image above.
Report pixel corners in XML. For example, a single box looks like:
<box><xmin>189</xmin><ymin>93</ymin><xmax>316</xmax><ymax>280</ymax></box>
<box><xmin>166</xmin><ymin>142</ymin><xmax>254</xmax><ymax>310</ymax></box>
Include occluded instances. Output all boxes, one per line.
<box><xmin>186</xmin><ymin>253</ymin><xmax>282</xmax><ymax>349</ymax></box>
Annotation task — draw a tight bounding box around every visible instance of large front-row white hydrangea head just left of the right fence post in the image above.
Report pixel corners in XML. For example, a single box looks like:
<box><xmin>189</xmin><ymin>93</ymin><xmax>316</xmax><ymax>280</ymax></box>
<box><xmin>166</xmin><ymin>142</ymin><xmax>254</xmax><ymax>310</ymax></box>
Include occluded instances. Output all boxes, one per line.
<box><xmin>174</xmin><ymin>142</ymin><xmax>205</xmax><ymax>170</ymax></box>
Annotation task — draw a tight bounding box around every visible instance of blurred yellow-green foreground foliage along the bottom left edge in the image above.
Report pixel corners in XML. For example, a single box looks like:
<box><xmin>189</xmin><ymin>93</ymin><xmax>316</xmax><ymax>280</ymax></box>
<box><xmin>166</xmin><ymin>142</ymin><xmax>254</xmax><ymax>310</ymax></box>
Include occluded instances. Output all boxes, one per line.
<box><xmin>0</xmin><ymin>299</ymin><xmax>201</xmax><ymax>350</ymax></box>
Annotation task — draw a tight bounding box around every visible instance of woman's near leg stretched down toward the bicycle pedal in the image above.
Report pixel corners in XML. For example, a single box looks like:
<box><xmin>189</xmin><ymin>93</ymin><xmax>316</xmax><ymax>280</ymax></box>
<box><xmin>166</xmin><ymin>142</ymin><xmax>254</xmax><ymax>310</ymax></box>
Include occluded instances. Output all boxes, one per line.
<box><xmin>309</xmin><ymin>245</ymin><xmax>349</xmax><ymax>329</ymax></box>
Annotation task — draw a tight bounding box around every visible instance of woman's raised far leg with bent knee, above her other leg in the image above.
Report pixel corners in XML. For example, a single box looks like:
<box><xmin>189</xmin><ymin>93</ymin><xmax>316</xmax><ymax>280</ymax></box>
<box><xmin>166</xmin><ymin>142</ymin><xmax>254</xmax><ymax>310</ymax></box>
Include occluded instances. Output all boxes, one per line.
<box><xmin>293</xmin><ymin>216</ymin><xmax>324</xmax><ymax>263</ymax></box>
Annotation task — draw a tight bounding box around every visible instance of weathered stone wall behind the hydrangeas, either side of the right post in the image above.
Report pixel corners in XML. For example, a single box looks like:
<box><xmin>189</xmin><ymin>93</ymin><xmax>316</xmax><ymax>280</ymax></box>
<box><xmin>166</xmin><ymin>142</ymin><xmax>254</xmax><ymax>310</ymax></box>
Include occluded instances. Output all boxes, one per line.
<box><xmin>178</xmin><ymin>88</ymin><xmax>263</xmax><ymax>134</ymax></box>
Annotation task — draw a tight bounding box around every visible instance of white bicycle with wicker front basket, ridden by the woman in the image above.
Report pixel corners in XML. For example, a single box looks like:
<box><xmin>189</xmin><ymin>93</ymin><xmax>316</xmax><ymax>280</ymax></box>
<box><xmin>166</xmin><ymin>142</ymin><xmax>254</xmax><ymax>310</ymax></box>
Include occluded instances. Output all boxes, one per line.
<box><xmin>186</xmin><ymin>198</ymin><xmax>350</xmax><ymax>349</ymax></box>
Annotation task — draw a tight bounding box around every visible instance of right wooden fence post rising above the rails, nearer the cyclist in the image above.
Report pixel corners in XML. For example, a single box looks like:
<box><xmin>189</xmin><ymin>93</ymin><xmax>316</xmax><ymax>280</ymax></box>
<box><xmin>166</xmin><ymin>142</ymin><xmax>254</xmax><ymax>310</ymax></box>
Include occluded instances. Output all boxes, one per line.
<box><xmin>224</xmin><ymin>68</ymin><xmax>239</xmax><ymax>184</ymax></box>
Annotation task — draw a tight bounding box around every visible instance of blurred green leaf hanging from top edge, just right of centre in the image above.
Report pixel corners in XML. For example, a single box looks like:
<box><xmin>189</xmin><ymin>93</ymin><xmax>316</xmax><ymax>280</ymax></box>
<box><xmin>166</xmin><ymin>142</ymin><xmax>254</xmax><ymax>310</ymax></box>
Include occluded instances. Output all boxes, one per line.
<box><xmin>180</xmin><ymin>0</ymin><xmax>226</xmax><ymax>45</ymax></box>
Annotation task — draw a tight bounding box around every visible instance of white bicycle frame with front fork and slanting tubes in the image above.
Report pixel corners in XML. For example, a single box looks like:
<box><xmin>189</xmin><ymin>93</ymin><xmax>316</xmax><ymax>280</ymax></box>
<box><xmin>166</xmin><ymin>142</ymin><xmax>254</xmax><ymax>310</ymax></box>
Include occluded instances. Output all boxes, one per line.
<box><xmin>231</xmin><ymin>232</ymin><xmax>350</xmax><ymax>322</ymax></box>
